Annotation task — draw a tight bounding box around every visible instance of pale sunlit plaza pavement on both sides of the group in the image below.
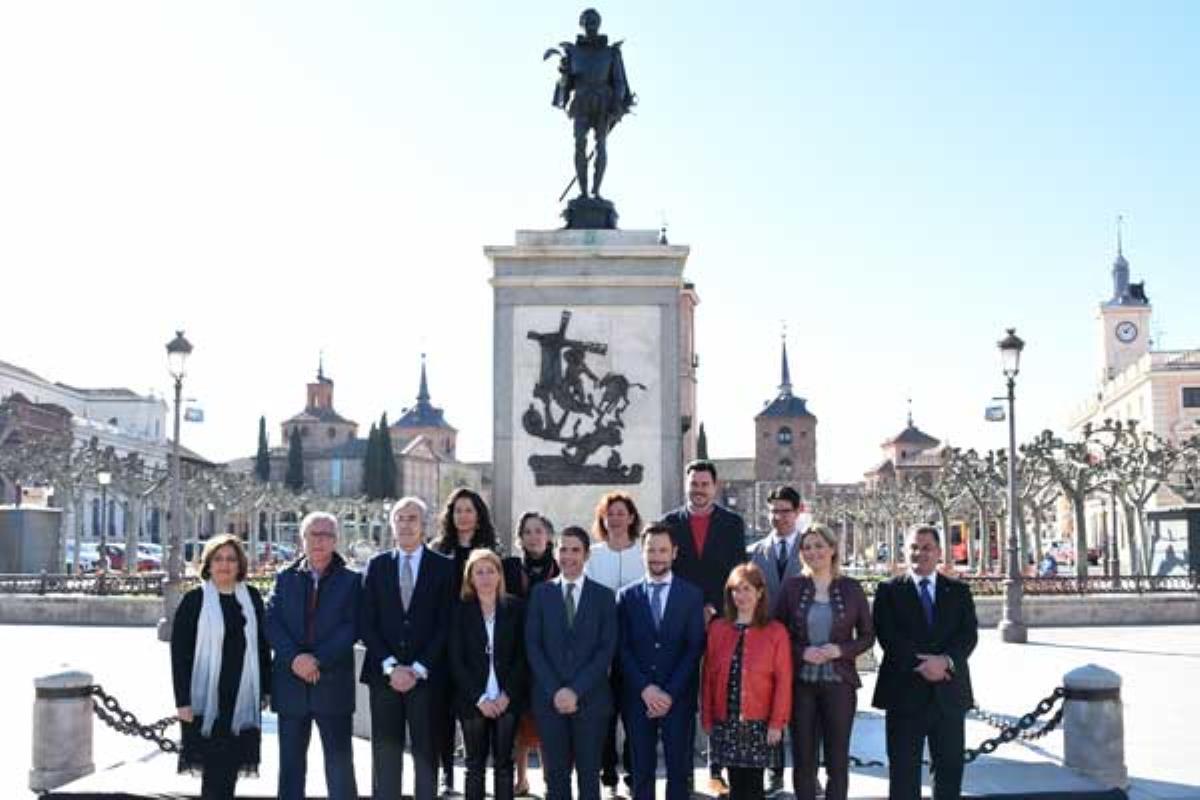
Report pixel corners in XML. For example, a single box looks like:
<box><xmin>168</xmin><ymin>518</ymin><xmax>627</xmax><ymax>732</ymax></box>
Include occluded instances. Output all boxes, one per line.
<box><xmin>0</xmin><ymin>626</ymin><xmax>1200</xmax><ymax>800</ymax></box>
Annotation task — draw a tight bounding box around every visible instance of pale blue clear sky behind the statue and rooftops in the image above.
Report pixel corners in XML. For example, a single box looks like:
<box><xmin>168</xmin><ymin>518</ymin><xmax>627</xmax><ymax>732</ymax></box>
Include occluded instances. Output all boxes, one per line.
<box><xmin>0</xmin><ymin>1</ymin><xmax>1200</xmax><ymax>480</ymax></box>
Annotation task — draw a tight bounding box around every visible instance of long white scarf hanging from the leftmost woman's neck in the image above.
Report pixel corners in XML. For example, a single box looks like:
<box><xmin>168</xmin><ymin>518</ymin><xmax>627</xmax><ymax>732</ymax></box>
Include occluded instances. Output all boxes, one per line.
<box><xmin>192</xmin><ymin>581</ymin><xmax>262</xmax><ymax>736</ymax></box>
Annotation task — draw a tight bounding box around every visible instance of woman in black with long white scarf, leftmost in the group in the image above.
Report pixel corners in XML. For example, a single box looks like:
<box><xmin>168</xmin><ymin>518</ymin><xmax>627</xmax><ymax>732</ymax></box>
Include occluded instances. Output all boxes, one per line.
<box><xmin>170</xmin><ymin>535</ymin><xmax>271</xmax><ymax>800</ymax></box>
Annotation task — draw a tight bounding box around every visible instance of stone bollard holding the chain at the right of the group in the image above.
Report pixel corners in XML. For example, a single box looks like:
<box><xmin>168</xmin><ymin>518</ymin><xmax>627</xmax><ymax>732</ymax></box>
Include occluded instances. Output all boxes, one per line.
<box><xmin>1062</xmin><ymin>664</ymin><xmax>1129</xmax><ymax>789</ymax></box>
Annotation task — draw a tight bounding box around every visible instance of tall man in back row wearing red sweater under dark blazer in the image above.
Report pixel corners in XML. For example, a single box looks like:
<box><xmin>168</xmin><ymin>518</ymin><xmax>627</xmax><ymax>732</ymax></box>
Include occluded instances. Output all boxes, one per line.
<box><xmin>662</xmin><ymin>461</ymin><xmax>746</xmax><ymax>795</ymax></box>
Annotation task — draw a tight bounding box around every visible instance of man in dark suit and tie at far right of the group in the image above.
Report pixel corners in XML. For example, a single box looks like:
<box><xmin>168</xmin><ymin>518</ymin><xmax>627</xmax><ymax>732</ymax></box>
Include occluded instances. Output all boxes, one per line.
<box><xmin>874</xmin><ymin>527</ymin><xmax>979</xmax><ymax>800</ymax></box>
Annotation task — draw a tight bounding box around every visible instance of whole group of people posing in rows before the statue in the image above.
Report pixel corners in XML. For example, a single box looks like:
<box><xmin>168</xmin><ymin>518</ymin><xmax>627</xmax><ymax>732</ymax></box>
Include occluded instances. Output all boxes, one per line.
<box><xmin>172</xmin><ymin>461</ymin><xmax>976</xmax><ymax>800</ymax></box>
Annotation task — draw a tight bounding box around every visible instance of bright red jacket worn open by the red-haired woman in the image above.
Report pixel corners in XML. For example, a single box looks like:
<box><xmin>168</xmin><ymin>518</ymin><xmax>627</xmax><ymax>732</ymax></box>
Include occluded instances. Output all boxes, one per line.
<box><xmin>701</xmin><ymin>619</ymin><xmax>792</xmax><ymax>730</ymax></box>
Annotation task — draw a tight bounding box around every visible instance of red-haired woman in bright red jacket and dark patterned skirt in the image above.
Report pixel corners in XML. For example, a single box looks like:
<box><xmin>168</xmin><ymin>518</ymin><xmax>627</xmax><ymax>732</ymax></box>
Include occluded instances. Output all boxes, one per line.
<box><xmin>701</xmin><ymin>564</ymin><xmax>792</xmax><ymax>800</ymax></box>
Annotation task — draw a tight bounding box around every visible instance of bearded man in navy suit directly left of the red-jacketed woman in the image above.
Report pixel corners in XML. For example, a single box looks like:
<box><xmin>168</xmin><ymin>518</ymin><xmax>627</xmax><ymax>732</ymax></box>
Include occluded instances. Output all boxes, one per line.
<box><xmin>617</xmin><ymin>523</ymin><xmax>704</xmax><ymax>800</ymax></box>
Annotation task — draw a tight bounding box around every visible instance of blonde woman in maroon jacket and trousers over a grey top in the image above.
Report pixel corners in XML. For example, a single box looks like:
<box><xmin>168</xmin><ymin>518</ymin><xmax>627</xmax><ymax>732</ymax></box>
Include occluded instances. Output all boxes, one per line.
<box><xmin>775</xmin><ymin>525</ymin><xmax>875</xmax><ymax>800</ymax></box>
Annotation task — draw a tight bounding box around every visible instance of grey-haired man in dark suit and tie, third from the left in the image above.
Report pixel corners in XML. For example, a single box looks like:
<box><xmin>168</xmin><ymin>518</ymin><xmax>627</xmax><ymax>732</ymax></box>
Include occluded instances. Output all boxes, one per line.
<box><xmin>360</xmin><ymin>498</ymin><xmax>454</xmax><ymax>800</ymax></box>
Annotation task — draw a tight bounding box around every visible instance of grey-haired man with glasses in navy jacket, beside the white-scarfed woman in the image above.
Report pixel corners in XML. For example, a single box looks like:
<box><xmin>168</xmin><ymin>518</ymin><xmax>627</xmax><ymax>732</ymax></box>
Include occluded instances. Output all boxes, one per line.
<box><xmin>266</xmin><ymin>511</ymin><xmax>359</xmax><ymax>800</ymax></box>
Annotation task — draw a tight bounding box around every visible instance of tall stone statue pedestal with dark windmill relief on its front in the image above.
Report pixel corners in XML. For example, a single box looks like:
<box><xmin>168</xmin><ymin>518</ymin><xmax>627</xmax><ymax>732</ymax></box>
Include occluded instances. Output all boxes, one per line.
<box><xmin>484</xmin><ymin>230</ymin><xmax>691</xmax><ymax>539</ymax></box>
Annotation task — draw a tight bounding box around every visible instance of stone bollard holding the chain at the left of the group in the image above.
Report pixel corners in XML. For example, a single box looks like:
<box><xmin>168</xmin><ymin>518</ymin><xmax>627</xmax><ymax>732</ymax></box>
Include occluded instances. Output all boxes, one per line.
<box><xmin>29</xmin><ymin>670</ymin><xmax>96</xmax><ymax>793</ymax></box>
